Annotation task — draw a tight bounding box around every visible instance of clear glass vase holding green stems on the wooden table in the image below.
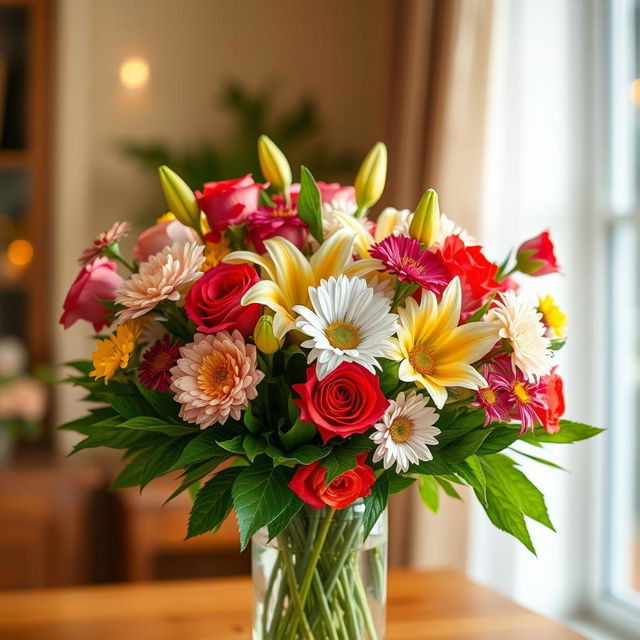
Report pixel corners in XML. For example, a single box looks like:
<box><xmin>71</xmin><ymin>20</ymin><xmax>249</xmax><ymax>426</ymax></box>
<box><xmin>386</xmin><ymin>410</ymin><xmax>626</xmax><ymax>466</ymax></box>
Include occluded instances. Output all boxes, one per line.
<box><xmin>252</xmin><ymin>501</ymin><xmax>387</xmax><ymax>640</ymax></box>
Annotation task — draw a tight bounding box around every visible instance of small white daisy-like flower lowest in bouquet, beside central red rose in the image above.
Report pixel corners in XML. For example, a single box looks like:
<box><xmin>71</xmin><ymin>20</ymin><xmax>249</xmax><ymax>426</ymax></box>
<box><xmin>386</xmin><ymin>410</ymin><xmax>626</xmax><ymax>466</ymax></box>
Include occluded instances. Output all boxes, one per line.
<box><xmin>370</xmin><ymin>391</ymin><xmax>440</xmax><ymax>473</ymax></box>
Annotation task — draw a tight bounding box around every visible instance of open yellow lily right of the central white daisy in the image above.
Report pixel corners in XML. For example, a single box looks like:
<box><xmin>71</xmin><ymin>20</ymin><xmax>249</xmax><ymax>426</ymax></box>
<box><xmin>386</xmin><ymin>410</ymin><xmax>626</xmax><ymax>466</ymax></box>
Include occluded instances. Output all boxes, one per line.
<box><xmin>389</xmin><ymin>278</ymin><xmax>498</xmax><ymax>409</ymax></box>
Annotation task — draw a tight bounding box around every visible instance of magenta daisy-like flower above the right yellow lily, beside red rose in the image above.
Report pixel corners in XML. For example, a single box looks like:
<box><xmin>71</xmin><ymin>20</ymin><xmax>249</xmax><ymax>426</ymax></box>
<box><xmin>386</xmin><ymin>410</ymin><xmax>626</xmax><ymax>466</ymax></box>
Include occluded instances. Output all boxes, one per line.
<box><xmin>370</xmin><ymin>235</ymin><xmax>447</xmax><ymax>293</ymax></box>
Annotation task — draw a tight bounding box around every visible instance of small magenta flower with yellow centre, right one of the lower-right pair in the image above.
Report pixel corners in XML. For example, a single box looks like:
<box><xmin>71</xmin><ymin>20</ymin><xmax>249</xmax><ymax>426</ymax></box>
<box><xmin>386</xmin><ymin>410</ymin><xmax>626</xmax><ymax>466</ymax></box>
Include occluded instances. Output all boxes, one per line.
<box><xmin>490</xmin><ymin>357</ymin><xmax>546</xmax><ymax>433</ymax></box>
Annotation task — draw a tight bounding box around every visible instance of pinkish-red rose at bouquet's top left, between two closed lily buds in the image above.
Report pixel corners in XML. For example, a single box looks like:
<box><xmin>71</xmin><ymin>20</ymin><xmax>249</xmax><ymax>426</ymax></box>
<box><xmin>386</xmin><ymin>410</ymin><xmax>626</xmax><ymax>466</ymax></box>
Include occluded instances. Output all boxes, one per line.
<box><xmin>196</xmin><ymin>173</ymin><xmax>264</xmax><ymax>232</ymax></box>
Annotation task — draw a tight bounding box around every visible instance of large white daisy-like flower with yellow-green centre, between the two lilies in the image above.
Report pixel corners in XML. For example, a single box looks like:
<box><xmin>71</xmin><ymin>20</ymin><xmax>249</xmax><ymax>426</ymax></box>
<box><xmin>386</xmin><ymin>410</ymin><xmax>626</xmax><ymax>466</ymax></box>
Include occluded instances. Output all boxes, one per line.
<box><xmin>293</xmin><ymin>275</ymin><xmax>398</xmax><ymax>380</ymax></box>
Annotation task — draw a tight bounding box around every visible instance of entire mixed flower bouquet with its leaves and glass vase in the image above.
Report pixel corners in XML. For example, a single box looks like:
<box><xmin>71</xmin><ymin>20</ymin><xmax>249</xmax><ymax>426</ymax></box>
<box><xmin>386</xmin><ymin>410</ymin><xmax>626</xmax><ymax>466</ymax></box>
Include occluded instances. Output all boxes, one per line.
<box><xmin>61</xmin><ymin>136</ymin><xmax>599</xmax><ymax>640</ymax></box>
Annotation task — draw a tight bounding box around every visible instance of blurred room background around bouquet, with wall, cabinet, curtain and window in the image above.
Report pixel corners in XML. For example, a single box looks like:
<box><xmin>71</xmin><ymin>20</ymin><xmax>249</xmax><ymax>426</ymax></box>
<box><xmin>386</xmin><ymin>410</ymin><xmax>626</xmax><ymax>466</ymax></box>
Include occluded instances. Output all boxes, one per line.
<box><xmin>0</xmin><ymin>0</ymin><xmax>640</xmax><ymax>638</ymax></box>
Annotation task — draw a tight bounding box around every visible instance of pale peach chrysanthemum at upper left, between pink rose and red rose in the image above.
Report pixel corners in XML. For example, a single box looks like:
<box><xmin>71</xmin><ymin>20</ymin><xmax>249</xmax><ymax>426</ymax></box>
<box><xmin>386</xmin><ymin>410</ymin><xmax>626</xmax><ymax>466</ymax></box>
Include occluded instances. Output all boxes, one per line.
<box><xmin>116</xmin><ymin>242</ymin><xmax>204</xmax><ymax>322</ymax></box>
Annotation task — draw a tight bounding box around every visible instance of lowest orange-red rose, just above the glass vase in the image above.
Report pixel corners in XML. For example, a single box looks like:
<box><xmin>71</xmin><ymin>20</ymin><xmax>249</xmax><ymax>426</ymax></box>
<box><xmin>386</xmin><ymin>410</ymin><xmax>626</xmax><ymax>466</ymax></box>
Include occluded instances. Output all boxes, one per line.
<box><xmin>289</xmin><ymin>453</ymin><xmax>376</xmax><ymax>509</ymax></box>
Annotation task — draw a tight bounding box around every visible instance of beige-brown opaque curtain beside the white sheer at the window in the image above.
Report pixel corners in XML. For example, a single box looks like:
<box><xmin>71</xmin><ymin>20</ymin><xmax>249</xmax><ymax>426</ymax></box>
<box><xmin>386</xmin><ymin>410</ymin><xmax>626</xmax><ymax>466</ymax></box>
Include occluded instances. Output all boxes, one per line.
<box><xmin>386</xmin><ymin>0</ymin><xmax>493</xmax><ymax>567</ymax></box>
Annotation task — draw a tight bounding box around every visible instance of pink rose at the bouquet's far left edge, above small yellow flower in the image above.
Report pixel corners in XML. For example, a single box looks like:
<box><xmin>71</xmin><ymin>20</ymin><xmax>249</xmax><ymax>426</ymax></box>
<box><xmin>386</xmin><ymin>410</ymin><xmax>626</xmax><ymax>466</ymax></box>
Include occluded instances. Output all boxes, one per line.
<box><xmin>60</xmin><ymin>258</ymin><xmax>123</xmax><ymax>331</ymax></box>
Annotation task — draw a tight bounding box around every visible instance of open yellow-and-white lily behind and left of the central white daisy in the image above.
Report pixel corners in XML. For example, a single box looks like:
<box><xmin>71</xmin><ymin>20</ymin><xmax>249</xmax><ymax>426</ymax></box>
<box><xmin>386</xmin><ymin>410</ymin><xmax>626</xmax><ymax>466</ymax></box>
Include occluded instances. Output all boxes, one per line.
<box><xmin>224</xmin><ymin>229</ymin><xmax>378</xmax><ymax>339</ymax></box>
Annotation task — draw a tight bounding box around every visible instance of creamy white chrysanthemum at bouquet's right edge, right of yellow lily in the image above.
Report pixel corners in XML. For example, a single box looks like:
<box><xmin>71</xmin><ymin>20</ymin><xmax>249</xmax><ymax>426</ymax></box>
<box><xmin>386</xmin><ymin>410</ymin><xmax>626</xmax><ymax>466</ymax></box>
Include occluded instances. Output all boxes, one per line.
<box><xmin>485</xmin><ymin>291</ymin><xmax>551</xmax><ymax>381</ymax></box>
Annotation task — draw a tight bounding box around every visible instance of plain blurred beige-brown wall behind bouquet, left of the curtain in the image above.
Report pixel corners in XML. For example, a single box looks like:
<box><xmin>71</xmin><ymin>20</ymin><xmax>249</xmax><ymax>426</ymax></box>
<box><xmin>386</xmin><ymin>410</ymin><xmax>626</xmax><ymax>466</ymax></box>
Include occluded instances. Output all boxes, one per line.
<box><xmin>52</xmin><ymin>0</ymin><xmax>390</xmax><ymax>436</ymax></box>
